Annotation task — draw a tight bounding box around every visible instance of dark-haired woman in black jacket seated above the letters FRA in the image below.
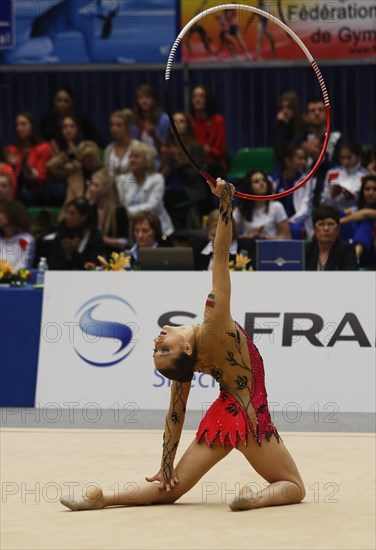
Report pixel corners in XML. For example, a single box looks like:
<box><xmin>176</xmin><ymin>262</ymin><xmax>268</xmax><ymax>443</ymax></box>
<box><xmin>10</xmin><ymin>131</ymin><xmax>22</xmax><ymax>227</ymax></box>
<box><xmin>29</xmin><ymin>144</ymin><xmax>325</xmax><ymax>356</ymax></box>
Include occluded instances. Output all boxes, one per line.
<box><xmin>305</xmin><ymin>205</ymin><xmax>358</xmax><ymax>271</ymax></box>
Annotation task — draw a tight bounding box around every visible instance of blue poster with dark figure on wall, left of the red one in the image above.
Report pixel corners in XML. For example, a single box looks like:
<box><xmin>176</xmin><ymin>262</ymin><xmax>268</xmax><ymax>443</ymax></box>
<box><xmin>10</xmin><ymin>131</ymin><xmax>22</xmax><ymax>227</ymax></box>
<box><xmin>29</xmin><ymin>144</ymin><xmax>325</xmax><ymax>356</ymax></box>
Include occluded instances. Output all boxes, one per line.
<box><xmin>0</xmin><ymin>0</ymin><xmax>176</xmax><ymax>65</ymax></box>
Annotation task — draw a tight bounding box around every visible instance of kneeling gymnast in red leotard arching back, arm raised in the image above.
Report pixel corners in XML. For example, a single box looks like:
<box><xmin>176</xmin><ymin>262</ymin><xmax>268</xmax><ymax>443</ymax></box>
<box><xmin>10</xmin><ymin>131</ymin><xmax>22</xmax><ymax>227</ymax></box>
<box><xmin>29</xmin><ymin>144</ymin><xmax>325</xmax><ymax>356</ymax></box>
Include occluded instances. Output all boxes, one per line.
<box><xmin>61</xmin><ymin>178</ymin><xmax>305</xmax><ymax>511</ymax></box>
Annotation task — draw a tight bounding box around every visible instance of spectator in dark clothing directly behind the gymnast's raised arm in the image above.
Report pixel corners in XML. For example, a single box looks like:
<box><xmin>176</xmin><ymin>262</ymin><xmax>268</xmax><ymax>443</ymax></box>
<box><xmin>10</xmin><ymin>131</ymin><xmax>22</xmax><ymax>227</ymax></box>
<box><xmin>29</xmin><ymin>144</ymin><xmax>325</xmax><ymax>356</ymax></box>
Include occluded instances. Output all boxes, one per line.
<box><xmin>192</xmin><ymin>209</ymin><xmax>256</xmax><ymax>271</ymax></box>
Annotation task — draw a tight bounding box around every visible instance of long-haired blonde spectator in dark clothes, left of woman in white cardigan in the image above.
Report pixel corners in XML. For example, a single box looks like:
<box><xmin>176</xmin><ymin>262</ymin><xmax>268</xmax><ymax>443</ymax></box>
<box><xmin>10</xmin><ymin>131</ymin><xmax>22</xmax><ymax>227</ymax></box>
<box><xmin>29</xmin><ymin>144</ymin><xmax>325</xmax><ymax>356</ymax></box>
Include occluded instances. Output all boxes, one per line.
<box><xmin>88</xmin><ymin>168</ymin><xmax>129</xmax><ymax>254</ymax></box>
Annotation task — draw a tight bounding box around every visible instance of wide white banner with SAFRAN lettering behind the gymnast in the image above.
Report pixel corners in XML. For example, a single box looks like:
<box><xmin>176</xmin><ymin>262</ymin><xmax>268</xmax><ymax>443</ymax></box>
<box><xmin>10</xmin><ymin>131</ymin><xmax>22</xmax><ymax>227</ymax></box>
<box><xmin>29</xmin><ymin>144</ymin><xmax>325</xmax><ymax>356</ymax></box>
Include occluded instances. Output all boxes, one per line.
<box><xmin>36</xmin><ymin>271</ymin><xmax>376</xmax><ymax>415</ymax></box>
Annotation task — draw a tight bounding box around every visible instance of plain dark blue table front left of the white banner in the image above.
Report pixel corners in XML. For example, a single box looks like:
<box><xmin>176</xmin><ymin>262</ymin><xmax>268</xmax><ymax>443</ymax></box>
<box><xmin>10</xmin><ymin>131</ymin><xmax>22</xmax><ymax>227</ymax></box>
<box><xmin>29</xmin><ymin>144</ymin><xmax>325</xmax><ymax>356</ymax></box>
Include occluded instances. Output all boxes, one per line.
<box><xmin>0</xmin><ymin>286</ymin><xmax>43</xmax><ymax>407</ymax></box>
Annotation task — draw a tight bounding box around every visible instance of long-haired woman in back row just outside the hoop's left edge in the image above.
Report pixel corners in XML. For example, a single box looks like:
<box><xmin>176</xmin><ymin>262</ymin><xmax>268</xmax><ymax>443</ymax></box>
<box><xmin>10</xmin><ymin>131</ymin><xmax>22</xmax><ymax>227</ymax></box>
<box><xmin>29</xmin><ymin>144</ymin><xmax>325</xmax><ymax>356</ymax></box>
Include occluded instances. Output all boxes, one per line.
<box><xmin>132</xmin><ymin>84</ymin><xmax>170</xmax><ymax>168</ymax></box>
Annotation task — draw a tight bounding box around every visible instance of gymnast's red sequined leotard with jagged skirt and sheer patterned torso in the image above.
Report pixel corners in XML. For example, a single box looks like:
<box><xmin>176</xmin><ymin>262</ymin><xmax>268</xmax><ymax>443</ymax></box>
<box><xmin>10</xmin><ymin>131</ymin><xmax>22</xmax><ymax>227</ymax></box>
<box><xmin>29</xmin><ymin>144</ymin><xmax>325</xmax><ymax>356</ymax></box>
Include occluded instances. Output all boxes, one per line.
<box><xmin>196</xmin><ymin>323</ymin><xmax>280</xmax><ymax>447</ymax></box>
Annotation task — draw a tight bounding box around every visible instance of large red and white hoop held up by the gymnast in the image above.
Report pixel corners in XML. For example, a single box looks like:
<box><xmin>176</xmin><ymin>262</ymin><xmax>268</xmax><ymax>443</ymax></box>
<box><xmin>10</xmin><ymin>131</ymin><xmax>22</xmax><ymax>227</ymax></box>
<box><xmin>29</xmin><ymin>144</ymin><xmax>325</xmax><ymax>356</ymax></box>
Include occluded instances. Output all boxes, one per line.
<box><xmin>165</xmin><ymin>4</ymin><xmax>330</xmax><ymax>201</ymax></box>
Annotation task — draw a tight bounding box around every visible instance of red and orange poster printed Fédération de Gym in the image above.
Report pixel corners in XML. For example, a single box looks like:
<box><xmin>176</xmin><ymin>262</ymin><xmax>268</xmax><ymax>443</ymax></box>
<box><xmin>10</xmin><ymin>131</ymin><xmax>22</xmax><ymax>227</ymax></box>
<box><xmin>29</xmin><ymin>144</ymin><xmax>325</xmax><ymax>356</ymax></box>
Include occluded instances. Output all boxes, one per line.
<box><xmin>180</xmin><ymin>0</ymin><xmax>376</xmax><ymax>63</ymax></box>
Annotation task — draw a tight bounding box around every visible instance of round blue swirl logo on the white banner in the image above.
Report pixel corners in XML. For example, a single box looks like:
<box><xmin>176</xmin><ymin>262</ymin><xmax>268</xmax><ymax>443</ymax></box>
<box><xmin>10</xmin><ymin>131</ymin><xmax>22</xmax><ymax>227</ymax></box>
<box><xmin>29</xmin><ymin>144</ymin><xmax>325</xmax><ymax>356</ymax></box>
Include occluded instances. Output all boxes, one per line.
<box><xmin>74</xmin><ymin>294</ymin><xmax>138</xmax><ymax>367</ymax></box>
